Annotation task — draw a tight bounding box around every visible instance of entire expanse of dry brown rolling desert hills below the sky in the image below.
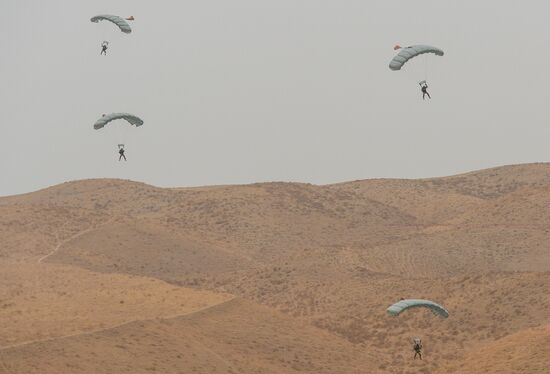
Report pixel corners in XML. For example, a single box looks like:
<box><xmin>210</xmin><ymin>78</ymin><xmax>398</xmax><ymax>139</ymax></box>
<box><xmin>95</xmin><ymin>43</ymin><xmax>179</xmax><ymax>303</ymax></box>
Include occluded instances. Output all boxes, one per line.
<box><xmin>0</xmin><ymin>163</ymin><xmax>550</xmax><ymax>373</ymax></box>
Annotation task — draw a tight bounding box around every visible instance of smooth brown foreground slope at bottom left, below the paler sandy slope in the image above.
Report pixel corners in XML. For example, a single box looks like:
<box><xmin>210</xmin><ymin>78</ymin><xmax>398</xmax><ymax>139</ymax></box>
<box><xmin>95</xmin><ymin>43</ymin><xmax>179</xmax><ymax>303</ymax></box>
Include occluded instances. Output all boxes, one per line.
<box><xmin>0</xmin><ymin>299</ymin><xmax>373</xmax><ymax>373</ymax></box>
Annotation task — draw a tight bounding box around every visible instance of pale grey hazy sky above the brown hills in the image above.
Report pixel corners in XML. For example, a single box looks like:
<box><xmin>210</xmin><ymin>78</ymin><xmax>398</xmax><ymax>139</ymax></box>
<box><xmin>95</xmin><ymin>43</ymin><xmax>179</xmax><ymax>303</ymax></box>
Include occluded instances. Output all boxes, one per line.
<box><xmin>0</xmin><ymin>0</ymin><xmax>550</xmax><ymax>195</ymax></box>
